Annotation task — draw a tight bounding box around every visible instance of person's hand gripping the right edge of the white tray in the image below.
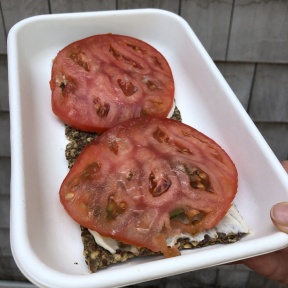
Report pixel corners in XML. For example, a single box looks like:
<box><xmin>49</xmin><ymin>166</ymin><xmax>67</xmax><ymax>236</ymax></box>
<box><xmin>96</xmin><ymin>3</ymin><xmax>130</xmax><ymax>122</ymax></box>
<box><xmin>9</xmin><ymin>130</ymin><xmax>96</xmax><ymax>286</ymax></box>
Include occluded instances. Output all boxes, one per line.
<box><xmin>238</xmin><ymin>161</ymin><xmax>288</xmax><ymax>285</ymax></box>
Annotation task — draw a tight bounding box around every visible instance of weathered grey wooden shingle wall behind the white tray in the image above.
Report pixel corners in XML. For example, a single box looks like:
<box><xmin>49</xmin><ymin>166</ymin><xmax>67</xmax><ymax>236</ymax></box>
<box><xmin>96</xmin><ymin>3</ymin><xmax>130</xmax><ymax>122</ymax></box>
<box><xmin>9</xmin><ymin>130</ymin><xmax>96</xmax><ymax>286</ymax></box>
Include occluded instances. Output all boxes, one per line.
<box><xmin>0</xmin><ymin>0</ymin><xmax>288</xmax><ymax>287</ymax></box>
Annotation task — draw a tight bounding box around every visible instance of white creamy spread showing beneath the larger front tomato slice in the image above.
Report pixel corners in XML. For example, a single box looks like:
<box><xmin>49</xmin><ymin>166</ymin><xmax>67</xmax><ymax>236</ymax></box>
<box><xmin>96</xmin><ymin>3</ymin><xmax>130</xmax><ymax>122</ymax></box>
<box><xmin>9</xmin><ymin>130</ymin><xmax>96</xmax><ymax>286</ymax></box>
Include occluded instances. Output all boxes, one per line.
<box><xmin>89</xmin><ymin>205</ymin><xmax>249</xmax><ymax>254</ymax></box>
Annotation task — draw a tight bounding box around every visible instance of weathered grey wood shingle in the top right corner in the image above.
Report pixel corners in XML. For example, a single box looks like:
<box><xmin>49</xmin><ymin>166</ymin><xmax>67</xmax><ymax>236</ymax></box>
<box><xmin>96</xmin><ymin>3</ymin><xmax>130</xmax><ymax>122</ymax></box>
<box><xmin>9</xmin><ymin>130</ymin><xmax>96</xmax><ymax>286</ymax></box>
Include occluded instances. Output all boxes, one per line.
<box><xmin>227</xmin><ymin>0</ymin><xmax>288</xmax><ymax>63</ymax></box>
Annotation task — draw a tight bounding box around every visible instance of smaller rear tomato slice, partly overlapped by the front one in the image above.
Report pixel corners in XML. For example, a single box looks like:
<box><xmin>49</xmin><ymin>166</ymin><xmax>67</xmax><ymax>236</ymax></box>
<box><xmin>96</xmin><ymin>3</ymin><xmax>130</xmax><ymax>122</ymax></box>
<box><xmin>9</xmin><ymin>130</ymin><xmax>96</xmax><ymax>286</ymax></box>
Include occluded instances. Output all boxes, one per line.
<box><xmin>50</xmin><ymin>34</ymin><xmax>174</xmax><ymax>132</ymax></box>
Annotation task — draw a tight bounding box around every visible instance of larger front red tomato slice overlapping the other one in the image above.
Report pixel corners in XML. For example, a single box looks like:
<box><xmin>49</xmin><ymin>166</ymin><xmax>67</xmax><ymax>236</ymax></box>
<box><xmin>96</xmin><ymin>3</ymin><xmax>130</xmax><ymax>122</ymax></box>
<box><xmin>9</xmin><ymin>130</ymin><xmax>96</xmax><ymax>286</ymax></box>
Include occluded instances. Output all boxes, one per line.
<box><xmin>60</xmin><ymin>116</ymin><xmax>238</xmax><ymax>257</ymax></box>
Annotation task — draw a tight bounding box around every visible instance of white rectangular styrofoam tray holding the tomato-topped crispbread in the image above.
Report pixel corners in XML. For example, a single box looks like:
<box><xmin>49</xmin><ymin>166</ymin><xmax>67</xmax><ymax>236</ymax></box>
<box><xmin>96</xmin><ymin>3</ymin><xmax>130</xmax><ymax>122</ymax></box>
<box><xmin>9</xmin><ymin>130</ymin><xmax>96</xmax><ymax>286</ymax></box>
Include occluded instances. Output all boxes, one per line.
<box><xmin>8</xmin><ymin>9</ymin><xmax>288</xmax><ymax>288</ymax></box>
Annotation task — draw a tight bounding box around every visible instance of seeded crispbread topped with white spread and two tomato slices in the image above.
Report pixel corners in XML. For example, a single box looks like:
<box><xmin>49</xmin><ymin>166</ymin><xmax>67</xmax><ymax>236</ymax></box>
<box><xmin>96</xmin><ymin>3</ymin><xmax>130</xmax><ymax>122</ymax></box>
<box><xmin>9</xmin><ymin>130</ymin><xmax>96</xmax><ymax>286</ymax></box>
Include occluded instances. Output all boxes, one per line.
<box><xmin>50</xmin><ymin>34</ymin><xmax>248</xmax><ymax>272</ymax></box>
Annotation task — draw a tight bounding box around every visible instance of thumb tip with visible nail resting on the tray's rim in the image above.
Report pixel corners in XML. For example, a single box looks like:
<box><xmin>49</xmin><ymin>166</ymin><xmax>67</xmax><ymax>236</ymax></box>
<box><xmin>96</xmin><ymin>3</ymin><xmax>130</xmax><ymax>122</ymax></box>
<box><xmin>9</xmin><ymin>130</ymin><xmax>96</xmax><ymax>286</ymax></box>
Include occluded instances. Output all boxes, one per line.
<box><xmin>270</xmin><ymin>202</ymin><xmax>288</xmax><ymax>233</ymax></box>
